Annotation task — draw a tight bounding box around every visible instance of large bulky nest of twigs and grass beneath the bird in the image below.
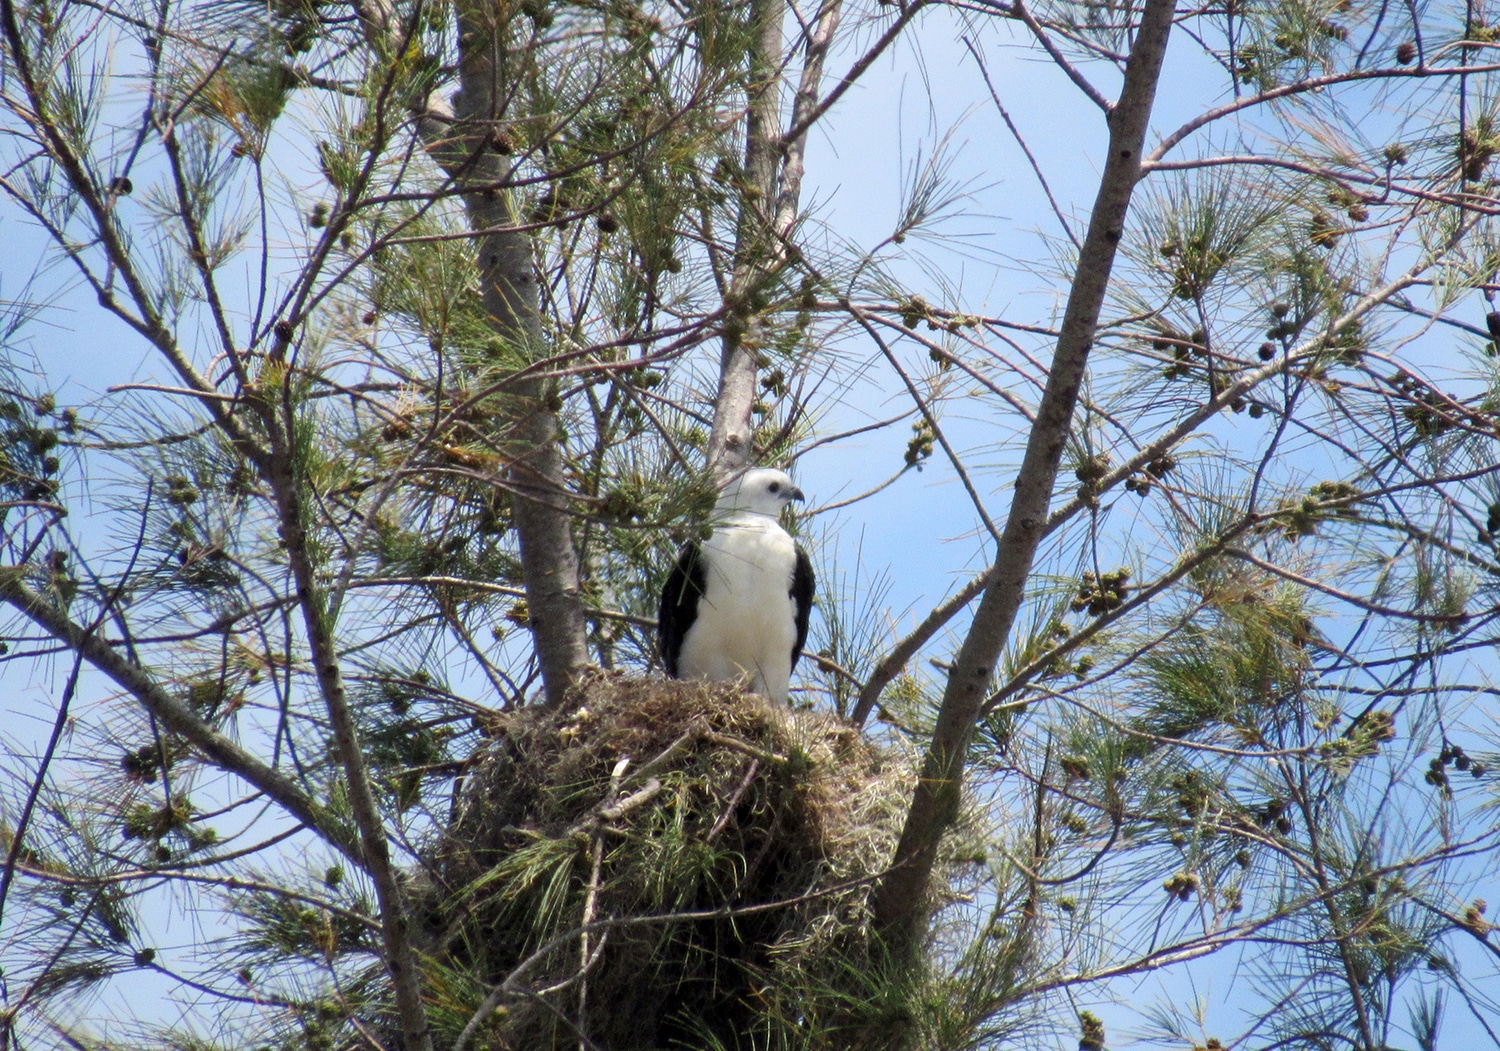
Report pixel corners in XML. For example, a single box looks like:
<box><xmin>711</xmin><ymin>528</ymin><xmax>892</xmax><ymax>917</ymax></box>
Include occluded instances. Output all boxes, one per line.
<box><xmin>414</xmin><ymin>675</ymin><xmax>912</xmax><ymax>1051</ymax></box>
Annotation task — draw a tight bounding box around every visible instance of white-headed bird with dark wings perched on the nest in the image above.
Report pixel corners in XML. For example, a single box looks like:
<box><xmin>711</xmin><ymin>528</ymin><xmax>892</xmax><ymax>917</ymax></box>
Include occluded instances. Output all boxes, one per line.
<box><xmin>657</xmin><ymin>468</ymin><xmax>815</xmax><ymax>705</ymax></box>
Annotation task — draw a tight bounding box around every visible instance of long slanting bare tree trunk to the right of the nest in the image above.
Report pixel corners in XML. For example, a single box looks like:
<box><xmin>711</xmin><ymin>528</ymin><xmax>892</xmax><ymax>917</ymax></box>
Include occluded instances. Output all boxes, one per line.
<box><xmin>872</xmin><ymin>0</ymin><xmax>1175</xmax><ymax>951</ymax></box>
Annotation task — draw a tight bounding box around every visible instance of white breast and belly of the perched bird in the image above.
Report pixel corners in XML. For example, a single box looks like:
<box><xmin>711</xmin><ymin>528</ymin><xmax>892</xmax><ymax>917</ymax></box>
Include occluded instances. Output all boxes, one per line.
<box><xmin>681</xmin><ymin>514</ymin><xmax>797</xmax><ymax>703</ymax></box>
